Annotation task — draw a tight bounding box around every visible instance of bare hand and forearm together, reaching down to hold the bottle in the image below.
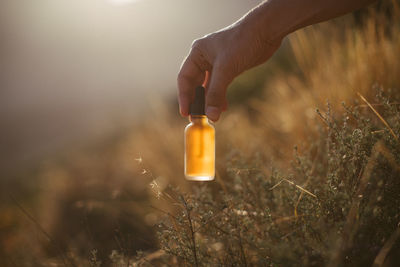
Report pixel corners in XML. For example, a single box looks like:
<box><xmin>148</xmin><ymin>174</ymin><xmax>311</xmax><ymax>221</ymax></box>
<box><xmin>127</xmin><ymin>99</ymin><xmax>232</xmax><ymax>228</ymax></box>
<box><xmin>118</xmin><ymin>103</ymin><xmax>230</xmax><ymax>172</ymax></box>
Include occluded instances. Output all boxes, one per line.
<box><xmin>177</xmin><ymin>0</ymin><xmax>374</xmax><ymax>121</ymax></box>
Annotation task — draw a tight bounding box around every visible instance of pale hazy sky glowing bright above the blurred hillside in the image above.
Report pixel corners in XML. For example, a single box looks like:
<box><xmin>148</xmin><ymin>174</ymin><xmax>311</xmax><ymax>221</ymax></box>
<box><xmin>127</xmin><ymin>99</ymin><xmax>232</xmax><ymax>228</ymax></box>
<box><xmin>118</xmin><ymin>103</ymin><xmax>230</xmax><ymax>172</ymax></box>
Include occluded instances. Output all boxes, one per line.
<box><xmin>0</xmin><ymin>0</ymin><xmax>259</xmax><ymax>174</ymax></box>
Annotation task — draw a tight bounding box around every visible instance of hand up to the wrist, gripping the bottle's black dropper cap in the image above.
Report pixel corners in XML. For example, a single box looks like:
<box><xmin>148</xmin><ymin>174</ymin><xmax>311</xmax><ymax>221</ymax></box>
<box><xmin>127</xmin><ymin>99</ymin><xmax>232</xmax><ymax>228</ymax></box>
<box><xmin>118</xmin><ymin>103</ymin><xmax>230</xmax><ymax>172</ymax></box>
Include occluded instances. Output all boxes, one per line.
<box><xmin>178</xmin><ymin>21</ymin><xmax>281</xmax><ymax>121</ymax></box>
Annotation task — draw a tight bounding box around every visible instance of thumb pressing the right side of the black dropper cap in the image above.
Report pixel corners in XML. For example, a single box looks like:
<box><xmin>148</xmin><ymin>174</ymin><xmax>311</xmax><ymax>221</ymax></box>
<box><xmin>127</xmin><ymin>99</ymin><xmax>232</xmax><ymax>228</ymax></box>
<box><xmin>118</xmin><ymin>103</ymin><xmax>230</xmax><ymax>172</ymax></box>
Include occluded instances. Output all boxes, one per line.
<box><xmin>206</xmin><ymin>66</ymin><xmax>232</xmax><ymax>121</ymax></box>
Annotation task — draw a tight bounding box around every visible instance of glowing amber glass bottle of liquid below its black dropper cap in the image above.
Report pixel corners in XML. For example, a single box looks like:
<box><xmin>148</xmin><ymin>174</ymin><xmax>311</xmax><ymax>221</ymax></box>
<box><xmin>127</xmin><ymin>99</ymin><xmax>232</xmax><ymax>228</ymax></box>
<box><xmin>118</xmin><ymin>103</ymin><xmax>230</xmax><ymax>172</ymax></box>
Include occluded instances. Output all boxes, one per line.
<box><xmin>185</xmin><ymin>115</ymin><xmax>215</xmax><ymax>181</ymax></box>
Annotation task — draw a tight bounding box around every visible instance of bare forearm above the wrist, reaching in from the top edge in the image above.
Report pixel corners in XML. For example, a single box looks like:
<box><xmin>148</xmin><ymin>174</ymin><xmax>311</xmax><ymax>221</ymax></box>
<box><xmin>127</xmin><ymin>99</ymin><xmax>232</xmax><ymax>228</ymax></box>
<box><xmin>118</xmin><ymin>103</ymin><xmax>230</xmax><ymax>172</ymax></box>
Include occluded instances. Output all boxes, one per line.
<box><xmin>235</xmin><ymin>0</ymin><xmax>375</xmax><ymax>43</ymax></box>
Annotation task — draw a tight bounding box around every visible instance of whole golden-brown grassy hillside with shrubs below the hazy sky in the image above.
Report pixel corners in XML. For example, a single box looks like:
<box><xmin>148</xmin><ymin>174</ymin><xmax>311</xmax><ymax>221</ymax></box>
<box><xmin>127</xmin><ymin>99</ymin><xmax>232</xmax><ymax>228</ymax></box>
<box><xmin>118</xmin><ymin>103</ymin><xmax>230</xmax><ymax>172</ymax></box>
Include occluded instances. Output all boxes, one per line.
<box><xmin>0</xmin><ymin>2</ymin><xmax>400</xmax><ymax>266</ymax></box>
